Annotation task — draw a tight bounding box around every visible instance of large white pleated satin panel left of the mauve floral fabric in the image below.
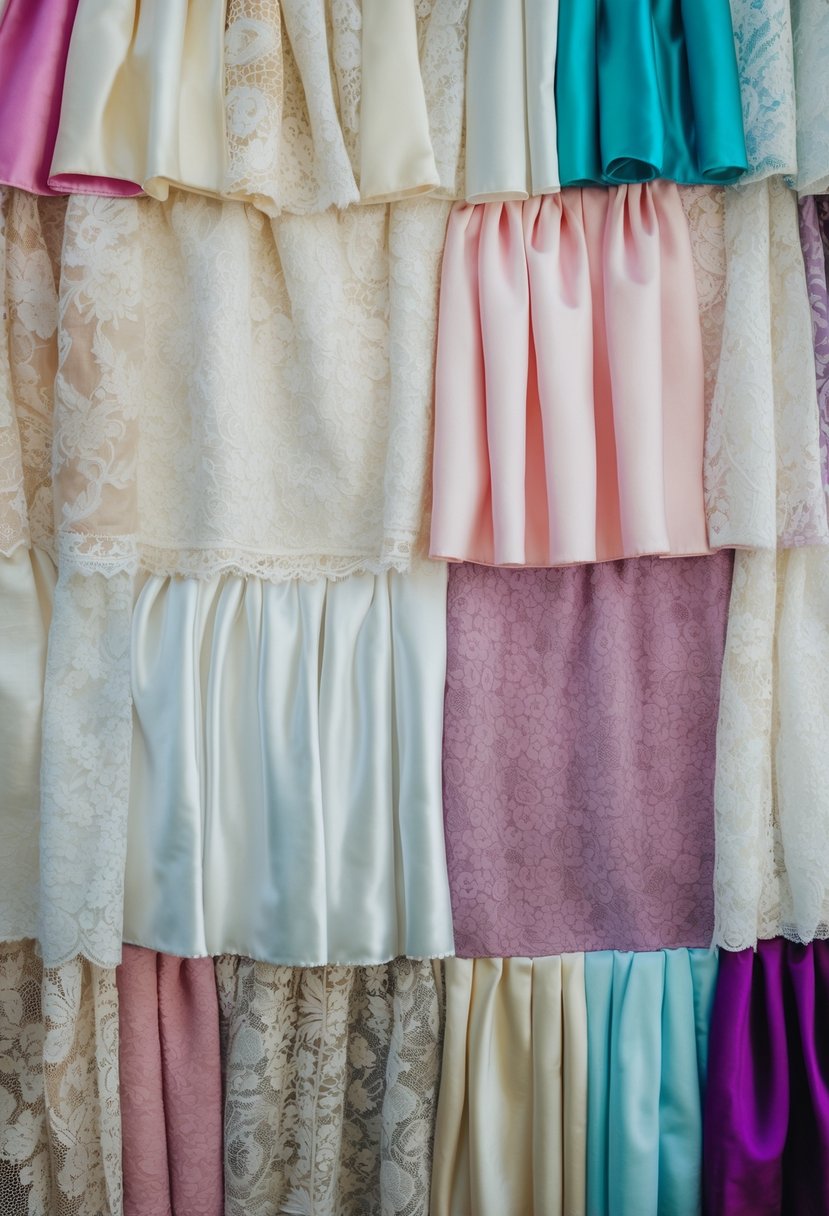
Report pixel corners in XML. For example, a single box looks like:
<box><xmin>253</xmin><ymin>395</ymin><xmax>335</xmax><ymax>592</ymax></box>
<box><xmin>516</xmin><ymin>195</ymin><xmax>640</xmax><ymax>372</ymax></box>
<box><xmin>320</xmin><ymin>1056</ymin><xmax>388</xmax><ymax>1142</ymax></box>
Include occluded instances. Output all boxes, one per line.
<box><xmin>124</xmin><ymin>564</ymin><xmax>453</xmax><ymax>966</ymax></box>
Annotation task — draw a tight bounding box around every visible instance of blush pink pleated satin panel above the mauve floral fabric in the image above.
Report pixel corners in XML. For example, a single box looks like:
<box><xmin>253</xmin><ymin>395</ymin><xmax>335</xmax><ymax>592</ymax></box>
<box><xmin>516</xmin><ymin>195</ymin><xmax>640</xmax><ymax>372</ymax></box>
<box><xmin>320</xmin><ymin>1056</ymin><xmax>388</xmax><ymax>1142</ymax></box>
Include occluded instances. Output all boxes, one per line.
<box><xmin>432</xmin><ymin>181</ymin><xmax>707</xmax><ymax>567</ymax></box>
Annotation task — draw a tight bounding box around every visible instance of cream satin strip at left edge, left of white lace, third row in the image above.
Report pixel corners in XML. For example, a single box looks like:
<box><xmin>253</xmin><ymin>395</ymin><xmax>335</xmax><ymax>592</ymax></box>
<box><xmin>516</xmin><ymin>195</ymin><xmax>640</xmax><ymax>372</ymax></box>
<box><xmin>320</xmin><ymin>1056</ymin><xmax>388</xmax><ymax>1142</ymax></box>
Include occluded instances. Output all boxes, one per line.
<box><xmin>0</xmin><ymin>548</ymin><xmax>55</xmax><ymax>941</ymax></box>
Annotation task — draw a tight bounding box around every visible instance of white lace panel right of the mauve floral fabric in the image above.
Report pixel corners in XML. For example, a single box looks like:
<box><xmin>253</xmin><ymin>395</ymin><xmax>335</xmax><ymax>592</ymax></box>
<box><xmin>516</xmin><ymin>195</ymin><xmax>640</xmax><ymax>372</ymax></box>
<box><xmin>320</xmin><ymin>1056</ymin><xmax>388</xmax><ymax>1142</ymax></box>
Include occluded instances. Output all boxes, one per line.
<box><xmin>715</xmin><ymin>548</ymin><xmax>829</xmax><ymax>950</ymax></box>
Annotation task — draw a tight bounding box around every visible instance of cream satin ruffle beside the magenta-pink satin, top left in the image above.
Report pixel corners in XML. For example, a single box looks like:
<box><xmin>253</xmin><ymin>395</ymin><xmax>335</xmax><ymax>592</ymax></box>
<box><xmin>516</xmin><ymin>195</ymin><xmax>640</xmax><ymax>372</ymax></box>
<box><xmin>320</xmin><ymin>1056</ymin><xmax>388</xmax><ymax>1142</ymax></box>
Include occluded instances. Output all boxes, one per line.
<box><xmin>49</xmin><ymin>0</ymin><xmax>226</xmax><ymax>199</ymax></box>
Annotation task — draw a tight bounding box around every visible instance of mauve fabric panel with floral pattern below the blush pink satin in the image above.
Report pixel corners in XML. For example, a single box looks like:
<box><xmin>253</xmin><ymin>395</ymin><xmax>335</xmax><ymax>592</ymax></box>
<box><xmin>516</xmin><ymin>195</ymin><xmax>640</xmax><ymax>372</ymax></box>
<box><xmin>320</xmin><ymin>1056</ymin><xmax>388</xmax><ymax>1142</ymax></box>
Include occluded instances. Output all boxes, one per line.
<box><xmin>444</xmin><ymin>553</ymin><xmax>732</xmax><ymax>957</ymax></box>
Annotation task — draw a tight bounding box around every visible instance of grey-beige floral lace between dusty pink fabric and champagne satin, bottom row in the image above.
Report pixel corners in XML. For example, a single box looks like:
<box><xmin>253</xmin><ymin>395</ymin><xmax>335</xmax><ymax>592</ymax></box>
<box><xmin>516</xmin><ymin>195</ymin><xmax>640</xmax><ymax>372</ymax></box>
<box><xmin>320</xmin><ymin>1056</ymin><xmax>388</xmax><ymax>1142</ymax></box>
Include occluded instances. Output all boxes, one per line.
<box><xmin>216</xmin><ymin>956</ymin><xmax>442</xmax><ymax>1216</ymax></box>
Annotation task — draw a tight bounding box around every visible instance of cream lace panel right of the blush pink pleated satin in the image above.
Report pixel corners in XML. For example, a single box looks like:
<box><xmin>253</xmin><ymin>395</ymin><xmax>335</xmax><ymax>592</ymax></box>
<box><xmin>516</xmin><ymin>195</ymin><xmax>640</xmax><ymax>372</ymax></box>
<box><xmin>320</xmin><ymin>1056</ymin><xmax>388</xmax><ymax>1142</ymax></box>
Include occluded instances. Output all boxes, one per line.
<box><xmin>705</xmin><ymin>178</ymin><xmax>829</xmax><ymax>548</ymax></box>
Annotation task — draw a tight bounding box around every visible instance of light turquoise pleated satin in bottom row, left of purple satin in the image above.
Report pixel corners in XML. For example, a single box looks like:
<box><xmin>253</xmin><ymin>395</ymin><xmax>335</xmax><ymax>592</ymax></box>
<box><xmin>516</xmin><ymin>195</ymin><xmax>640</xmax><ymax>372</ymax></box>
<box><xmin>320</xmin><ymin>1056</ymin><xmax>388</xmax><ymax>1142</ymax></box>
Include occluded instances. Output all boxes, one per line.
<box><xmin>585</xmin><ymin>950</ymin><xmax>717</xmax><ymax>1216</ymax></box>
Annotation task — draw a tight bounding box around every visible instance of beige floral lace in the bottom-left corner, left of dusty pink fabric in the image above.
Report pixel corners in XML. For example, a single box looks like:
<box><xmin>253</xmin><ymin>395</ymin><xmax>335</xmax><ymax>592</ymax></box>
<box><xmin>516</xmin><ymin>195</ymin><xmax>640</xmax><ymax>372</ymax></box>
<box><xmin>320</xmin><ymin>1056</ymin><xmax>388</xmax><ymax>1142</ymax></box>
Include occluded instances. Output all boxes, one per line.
<box><xmin>0</xmin><ymin>941</ymin><xmax>123</xmax><ymax>1216</ymax></box>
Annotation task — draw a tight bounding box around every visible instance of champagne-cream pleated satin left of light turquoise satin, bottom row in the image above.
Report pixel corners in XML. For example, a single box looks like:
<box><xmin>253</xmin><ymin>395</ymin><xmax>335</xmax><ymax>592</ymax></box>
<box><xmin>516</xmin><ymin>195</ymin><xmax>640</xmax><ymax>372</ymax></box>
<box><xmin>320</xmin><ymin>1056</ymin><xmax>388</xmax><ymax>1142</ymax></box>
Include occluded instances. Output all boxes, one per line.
<box><xmin>430</xmin><ymin>955</ymin><xmax>587</xmax><ymax>1216</ymax></box>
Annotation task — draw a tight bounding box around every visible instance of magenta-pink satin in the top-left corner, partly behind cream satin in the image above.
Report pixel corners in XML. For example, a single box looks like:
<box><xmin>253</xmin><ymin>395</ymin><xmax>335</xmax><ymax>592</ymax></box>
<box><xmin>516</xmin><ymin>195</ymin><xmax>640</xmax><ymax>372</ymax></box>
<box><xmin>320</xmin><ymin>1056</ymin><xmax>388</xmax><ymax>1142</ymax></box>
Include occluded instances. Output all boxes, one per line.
<box><xmin>0</xmin><ymin>0</ymin><xmax>130</xmax><ymax>195</ymax></box>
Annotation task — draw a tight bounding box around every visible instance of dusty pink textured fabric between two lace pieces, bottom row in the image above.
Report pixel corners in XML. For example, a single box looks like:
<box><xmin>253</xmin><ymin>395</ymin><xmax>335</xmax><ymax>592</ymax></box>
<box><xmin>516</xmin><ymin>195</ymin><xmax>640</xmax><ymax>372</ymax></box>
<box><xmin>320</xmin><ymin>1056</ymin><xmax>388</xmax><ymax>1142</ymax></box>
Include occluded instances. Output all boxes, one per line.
<box><xmin>117</xmin><ymin>946</ymin><xmax>224</xmax><ymax>1216</ymax></box>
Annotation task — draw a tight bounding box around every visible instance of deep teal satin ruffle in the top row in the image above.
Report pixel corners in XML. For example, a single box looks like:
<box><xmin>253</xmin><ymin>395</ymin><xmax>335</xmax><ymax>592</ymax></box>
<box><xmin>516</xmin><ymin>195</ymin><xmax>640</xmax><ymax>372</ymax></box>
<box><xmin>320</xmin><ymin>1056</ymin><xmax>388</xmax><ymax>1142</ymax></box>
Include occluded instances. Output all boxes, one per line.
<box><xmin>556</xmin><ymin>0</ymin><xmax>748</xmax><ymax>186</ymax></box>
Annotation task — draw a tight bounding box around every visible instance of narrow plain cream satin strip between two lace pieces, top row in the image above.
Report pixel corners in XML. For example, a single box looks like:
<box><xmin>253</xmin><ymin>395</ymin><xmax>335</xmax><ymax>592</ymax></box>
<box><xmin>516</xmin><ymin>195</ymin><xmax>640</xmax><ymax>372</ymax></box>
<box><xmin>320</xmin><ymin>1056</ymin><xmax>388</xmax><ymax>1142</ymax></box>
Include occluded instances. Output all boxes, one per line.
<box><xmin>360</xmin><ymin>0</ymin><xmax>440</xmax><ymax>203</ymax></box>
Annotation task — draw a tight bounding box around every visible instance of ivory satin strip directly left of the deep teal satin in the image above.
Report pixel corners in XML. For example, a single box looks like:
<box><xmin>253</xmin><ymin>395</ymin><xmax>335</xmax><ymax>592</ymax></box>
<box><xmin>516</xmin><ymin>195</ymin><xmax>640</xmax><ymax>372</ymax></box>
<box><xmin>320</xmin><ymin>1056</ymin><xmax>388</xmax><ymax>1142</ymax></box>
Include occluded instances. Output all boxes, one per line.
<box><xmin>466</xmin><ymin>0</ymin><xmax>559</xmax><ymax>203</ymax></box>
